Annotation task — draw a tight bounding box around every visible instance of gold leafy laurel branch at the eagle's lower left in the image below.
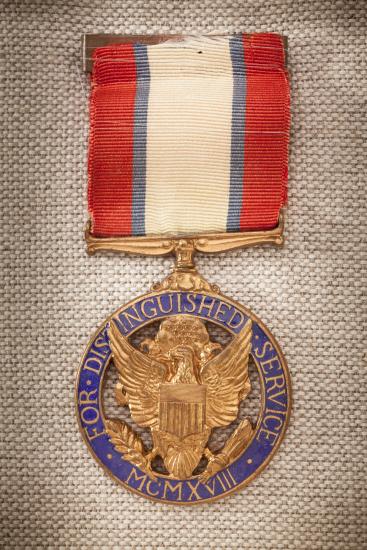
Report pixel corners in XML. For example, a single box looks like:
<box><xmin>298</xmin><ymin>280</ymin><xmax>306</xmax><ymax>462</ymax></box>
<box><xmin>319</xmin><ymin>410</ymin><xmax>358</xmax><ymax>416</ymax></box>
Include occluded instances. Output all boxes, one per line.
<box><xmin>106</xmin><ymin>420</ymin><xmax>156</xmax><ymax>480</ymax></box>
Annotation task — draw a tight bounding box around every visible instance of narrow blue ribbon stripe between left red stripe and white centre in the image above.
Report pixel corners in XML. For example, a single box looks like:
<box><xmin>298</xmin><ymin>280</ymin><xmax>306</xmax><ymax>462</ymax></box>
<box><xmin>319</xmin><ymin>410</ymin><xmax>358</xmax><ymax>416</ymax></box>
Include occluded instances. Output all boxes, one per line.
<box><xmin>132</xmin><ymin>44</ymin><xmax>150</xmax><ymax>235</ymax></box>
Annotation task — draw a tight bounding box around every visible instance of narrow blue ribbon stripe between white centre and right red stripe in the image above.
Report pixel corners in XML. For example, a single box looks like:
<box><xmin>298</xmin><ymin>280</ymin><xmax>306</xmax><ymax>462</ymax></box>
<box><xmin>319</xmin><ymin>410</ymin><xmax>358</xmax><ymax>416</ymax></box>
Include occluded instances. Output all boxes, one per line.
<box><xmin>227</xmin><ymin>36</ymin><xmax>246</xmax><ymax>231</ymax></box>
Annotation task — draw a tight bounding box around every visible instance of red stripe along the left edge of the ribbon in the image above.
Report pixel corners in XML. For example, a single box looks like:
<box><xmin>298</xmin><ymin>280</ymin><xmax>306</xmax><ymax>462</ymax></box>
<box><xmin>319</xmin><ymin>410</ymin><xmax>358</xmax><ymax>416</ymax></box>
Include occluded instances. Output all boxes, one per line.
<box><xmin>88</xmin><ymin>44</ymin><xmax>136</xmax><ymax>237</ymax></box>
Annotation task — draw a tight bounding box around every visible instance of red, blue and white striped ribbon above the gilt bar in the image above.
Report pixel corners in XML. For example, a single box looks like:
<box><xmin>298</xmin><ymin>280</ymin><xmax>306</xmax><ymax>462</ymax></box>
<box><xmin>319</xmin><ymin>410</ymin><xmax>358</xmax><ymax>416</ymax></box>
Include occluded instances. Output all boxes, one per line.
<box><xmin>89</xmin><ymin>34</ymin><xmax>289</xmax><ymax>237</ymax></box>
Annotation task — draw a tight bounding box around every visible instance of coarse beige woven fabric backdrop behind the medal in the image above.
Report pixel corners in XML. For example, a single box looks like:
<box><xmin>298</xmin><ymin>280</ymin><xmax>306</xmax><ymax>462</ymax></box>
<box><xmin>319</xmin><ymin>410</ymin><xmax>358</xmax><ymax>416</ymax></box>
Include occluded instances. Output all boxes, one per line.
<box><xmin>0</xmin><ymin>0</ymin><xmax>367</xmax><ymax>550</ymax></box>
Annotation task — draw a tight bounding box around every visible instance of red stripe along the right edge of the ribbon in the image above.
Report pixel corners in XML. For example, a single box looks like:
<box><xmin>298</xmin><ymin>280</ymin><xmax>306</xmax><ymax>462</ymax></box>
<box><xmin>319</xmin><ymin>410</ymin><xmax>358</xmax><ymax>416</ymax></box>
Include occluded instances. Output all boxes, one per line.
<box><xmin>240</xmin><ymin>34</ymin><xmax>290</xmax><ymax>231</ymax></box>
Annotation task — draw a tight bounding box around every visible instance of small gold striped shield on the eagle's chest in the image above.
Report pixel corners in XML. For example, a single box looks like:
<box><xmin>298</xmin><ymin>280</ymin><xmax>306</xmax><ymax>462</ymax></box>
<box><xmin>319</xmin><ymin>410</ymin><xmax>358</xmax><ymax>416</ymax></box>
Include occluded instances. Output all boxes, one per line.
<box><xmin>159</xmin><ymin>384</ymin><xmax>206</xmax><ymax>438</ymax></box>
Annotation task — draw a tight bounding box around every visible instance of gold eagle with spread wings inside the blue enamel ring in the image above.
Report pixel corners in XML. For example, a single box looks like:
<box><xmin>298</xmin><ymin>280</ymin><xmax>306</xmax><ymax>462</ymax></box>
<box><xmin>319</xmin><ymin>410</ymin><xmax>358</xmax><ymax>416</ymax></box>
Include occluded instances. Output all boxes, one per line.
<box><xmin>109</xmin><ymin>315</ymin><xmax>252</xmax><ymax>480</ymax></box>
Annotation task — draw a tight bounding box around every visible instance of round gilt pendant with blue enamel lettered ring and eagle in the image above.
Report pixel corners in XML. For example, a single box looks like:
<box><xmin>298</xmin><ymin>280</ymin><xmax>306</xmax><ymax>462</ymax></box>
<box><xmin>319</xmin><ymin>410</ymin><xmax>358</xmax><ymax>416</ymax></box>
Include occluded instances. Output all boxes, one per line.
<box><xmin>76</xmin><ymin>266</ymin><xmax>291</xmax><ymax>504</ymax></box>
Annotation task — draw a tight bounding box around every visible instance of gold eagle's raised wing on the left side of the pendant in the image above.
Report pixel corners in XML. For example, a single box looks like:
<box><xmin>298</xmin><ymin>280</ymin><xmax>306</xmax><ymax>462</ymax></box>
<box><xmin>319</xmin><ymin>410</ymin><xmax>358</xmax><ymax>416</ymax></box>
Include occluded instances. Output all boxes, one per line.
<box><xmin>108</xmin><ymin>321</ymin><xmax>166</xmax><ymax>427</ymax></box>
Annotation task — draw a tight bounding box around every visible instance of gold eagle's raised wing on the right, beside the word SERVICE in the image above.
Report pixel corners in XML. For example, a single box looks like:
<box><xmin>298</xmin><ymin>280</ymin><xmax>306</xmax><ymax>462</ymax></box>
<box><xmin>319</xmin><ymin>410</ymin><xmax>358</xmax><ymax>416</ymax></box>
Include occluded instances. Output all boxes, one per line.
<box><xmin>201</xmin><ymin>319</ymin><xmax>252</xmax><ymax>428</ymax></box>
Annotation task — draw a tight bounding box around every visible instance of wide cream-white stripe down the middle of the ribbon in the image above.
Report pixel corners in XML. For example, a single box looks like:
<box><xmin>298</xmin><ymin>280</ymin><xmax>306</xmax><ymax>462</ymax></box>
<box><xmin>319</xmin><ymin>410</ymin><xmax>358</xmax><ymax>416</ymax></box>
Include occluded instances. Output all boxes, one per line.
<box><xmin>145</xmin><ymin>39</ymin><xmax>233</xmax><ymax>234</ymax></box>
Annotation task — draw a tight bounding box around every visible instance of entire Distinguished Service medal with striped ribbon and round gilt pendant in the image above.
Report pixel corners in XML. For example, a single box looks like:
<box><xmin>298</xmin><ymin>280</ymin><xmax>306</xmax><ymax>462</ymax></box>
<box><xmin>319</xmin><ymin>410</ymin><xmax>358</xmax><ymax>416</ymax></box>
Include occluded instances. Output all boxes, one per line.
<box><xmin>76</xmin><ymin>34</ymin><xmax>291</xmax><ymax>504</ymax></box>
